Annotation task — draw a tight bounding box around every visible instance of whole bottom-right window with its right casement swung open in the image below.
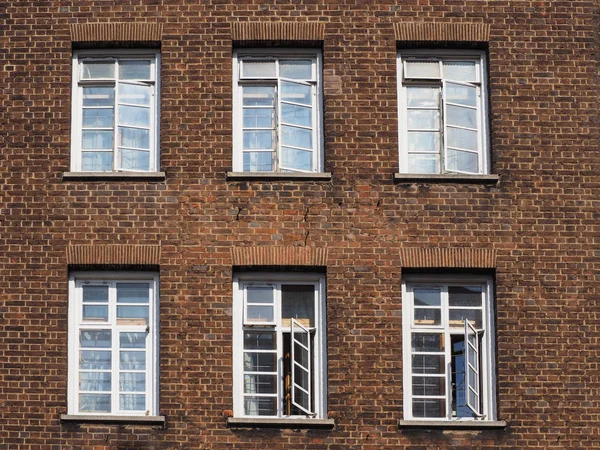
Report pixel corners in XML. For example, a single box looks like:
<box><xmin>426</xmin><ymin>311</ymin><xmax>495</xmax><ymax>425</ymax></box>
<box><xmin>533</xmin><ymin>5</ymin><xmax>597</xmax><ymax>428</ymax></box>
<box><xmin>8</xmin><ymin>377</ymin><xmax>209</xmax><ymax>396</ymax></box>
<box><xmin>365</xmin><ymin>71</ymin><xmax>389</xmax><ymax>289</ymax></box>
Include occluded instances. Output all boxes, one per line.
<box><xmin>402</xmin><ymin>276</ymin><xmax>496</xmax><ymax>421</ymax></box>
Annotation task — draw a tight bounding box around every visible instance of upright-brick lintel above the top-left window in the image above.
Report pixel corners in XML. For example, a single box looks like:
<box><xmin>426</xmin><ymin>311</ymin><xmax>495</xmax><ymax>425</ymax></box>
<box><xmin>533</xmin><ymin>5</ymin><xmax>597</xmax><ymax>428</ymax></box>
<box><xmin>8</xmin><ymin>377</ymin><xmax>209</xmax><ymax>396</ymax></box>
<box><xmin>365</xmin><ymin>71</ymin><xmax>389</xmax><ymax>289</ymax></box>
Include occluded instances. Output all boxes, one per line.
<box><xmin>71</xmin><ymin>22</ymin><xmax>163</xmax><ymax>42</ymax></box>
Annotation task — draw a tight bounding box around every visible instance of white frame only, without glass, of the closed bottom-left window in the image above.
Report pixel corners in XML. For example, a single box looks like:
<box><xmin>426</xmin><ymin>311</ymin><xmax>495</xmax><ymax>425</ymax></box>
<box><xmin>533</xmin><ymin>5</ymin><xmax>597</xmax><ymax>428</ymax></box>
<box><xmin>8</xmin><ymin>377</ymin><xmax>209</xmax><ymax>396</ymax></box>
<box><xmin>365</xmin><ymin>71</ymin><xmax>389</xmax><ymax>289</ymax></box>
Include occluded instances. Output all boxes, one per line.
<box><xmin>68</xmin><ymin>271</ymin><xmax>159</xmax><ymax>417</ymax></box>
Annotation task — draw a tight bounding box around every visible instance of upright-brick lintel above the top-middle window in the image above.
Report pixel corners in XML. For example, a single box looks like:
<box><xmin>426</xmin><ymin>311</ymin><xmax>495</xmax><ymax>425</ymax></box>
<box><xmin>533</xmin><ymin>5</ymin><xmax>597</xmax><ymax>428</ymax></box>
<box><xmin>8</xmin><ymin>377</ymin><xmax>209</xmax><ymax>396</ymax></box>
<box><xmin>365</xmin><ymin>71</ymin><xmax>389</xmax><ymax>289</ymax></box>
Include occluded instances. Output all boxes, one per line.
<box><xmin>231</xmin><ymin>22</ymin><xmax>325</xmax><ymax>41</ymax></box>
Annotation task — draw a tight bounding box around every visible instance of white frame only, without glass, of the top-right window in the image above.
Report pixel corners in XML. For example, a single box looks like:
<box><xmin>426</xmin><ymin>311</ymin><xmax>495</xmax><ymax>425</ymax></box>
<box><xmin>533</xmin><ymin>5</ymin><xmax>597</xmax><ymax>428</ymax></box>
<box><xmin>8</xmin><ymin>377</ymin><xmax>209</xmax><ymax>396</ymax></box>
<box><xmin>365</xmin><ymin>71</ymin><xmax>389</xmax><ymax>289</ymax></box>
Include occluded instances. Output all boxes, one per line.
<box><xmin>396</xmin><ymin>49</ymin><xmax>491</xmax><ymax>176</ymax></box>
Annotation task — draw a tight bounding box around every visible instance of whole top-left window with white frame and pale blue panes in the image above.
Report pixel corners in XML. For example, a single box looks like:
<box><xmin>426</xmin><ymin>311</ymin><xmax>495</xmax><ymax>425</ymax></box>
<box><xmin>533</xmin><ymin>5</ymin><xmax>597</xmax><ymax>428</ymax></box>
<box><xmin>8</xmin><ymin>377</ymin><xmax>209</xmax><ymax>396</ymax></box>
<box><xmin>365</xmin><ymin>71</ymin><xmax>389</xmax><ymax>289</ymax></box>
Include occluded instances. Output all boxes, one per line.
<box><xmin>71</xmin><ymin>51</ymin><xmax>159</xmax><ymax>172</ymax></box>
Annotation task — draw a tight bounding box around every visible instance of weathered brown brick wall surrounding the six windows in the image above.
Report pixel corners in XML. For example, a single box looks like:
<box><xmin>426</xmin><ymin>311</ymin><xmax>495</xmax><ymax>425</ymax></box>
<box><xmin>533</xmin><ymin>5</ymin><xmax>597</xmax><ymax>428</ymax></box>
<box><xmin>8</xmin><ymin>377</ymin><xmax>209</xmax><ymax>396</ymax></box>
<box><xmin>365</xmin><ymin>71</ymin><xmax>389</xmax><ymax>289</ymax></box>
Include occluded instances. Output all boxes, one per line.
<box><xmin>0</xmin><ymin>0</ymin><xmax>600</xmax><ymax>450</ymax></box>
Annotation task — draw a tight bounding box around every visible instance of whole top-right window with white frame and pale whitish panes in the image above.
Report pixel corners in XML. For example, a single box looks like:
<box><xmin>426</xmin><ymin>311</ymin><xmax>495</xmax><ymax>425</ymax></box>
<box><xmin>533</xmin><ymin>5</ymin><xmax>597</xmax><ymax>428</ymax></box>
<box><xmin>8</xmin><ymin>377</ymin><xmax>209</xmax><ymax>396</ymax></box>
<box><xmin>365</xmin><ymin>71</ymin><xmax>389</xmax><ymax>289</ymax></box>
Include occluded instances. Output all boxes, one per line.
<box><xmin>398</xmin><ymin>50</ymin><xmax>489</xmax><ymax>175</ymax></box>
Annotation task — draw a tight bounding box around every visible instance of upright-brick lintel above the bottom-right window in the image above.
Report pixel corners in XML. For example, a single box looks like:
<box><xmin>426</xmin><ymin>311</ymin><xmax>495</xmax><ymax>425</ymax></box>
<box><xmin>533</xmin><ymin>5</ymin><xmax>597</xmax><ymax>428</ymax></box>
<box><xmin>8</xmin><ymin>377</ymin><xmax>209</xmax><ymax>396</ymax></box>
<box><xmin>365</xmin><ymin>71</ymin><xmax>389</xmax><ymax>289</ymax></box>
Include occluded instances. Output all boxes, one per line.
<box><xmin>400</xmin><ymin>248</ymin><xmax>496</xmax><ymax>269</ymax></box>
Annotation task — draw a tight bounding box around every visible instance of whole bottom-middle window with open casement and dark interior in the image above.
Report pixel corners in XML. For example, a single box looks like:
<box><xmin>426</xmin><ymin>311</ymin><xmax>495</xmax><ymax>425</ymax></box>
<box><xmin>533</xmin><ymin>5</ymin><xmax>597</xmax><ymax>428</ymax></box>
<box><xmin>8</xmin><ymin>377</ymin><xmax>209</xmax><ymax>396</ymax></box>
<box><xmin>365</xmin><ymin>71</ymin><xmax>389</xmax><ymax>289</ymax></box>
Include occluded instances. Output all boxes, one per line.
<box><xmin>233</xmin><ymin>274</ymin><xmax>325</xmax><ymax>418</ymax></box>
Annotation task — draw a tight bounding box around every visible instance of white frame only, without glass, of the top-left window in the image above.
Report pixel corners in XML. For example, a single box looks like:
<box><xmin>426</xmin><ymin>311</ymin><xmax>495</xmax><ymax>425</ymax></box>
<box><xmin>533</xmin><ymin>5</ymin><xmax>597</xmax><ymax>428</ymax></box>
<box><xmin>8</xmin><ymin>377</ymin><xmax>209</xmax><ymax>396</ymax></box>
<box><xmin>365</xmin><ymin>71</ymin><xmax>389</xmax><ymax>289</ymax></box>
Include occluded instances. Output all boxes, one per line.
<box><xmin>71</xmin><ymin>49</ymin><xmax>160</xmax><ymax>173</ymax></box>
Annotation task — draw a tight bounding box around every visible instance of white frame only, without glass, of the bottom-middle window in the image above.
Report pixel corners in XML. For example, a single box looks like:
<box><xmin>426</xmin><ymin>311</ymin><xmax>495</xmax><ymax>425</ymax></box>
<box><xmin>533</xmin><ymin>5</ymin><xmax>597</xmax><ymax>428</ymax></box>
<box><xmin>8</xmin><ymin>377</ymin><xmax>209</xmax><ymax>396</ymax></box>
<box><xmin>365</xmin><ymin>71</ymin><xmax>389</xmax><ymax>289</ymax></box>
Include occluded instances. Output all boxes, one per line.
<box><xmin>233</xmin><ymin>272</ymin><xmax>327</xmax><ymax>420</ymax></box>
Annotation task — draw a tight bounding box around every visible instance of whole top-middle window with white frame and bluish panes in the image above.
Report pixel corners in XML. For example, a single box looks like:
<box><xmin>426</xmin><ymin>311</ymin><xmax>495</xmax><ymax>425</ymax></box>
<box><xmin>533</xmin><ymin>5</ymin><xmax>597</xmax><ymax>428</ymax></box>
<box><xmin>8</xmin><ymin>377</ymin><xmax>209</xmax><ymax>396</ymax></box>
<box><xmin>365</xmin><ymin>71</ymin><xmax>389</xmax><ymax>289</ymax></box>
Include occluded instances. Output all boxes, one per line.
<box><xmin>233</xmin><ymin>50</ymin><xmax>323</xmax><ymax>172</ymax></box>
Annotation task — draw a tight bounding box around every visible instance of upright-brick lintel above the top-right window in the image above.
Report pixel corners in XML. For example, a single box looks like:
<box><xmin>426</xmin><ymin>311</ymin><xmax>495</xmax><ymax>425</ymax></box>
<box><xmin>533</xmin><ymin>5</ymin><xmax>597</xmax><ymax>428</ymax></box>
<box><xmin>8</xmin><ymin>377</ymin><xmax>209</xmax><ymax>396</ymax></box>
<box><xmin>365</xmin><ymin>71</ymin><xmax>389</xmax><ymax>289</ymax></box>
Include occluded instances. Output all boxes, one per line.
<box><xmin>394</xmin><ymin>22</ymin><xmax>490</xmax><ymax>42</ymax></box>
